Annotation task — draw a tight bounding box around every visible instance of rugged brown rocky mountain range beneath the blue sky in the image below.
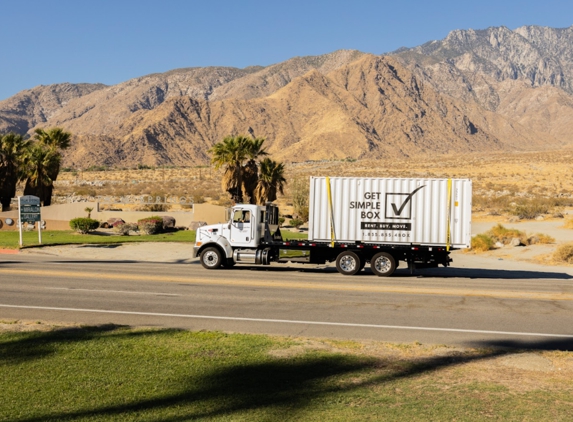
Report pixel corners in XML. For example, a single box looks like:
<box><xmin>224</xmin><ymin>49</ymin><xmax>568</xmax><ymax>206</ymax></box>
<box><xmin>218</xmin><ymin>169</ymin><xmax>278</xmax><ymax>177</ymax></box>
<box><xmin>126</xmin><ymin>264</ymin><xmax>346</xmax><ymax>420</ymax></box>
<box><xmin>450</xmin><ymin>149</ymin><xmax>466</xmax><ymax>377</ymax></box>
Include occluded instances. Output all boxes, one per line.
<box><xmin>0</xmin><ymin>26</ymin><xmax>573</xmax><ymax>168</ymax></box>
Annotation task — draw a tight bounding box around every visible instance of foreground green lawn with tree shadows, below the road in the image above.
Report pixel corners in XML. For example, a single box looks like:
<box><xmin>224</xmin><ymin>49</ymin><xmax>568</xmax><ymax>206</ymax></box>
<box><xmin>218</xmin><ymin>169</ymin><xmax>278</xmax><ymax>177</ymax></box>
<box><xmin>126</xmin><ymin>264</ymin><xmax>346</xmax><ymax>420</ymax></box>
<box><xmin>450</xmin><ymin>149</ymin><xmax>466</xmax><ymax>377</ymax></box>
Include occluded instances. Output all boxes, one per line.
<box><xmin>0</xmin><ymin>325</ymin><xmax>573</xmax><ymax>421</ymax></box>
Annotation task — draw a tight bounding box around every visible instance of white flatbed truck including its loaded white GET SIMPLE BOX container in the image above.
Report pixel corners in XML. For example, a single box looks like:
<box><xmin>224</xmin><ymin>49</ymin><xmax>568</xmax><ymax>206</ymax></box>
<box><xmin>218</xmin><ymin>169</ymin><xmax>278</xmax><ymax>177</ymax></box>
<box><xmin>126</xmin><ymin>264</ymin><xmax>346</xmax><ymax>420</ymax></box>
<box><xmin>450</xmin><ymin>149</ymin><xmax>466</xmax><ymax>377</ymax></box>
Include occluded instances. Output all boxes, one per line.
<box><xmin>193</xmin><ymin>177</ymin><xmax>472</xmax><ymax>277</ymax></box>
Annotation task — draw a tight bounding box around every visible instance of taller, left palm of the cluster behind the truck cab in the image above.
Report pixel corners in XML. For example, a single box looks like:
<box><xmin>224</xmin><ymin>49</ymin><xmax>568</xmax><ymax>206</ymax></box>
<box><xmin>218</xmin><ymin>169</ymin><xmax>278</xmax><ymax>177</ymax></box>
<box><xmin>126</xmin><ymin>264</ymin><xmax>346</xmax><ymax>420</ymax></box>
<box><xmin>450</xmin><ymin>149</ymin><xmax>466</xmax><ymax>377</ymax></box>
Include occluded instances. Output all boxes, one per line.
<box><xmin>209</xmin><ymin>135</ymin><xmax>266</xmax><ymax>203</ymax></box>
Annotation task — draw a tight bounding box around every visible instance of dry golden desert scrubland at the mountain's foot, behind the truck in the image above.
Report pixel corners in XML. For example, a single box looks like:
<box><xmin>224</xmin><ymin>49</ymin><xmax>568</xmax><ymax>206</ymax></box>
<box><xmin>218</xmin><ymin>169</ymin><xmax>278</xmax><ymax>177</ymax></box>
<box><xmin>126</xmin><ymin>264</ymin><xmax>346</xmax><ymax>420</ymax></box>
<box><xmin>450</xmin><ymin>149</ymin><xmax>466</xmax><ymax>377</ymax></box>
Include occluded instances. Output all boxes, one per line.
<box><xmin>47</xmin><ymin>150</ymin><xmax>573</xmax><ymax>221</ymax></box>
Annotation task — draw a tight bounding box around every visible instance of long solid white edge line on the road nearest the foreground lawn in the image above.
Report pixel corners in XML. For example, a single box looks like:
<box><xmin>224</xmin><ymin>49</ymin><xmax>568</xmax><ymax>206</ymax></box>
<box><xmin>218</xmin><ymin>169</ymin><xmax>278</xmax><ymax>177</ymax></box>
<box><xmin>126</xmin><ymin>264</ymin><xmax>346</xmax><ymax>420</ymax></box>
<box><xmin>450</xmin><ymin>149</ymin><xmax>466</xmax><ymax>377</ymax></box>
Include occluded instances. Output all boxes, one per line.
<box><xmin>0</xmin><ymin>304</ymin><xmax>573</xmax><ymax>338</ymax></box>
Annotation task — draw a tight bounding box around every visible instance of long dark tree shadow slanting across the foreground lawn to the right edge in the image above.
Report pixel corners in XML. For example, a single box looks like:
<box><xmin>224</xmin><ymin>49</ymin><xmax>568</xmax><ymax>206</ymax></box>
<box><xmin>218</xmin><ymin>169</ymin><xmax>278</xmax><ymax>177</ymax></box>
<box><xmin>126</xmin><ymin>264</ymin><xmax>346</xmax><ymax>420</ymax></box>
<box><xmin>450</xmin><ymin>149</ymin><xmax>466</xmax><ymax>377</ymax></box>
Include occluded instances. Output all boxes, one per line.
<box><xmin>5</xmin><ymin>326</ymin><xmax>569</xmax><ymax>422</ymax></box>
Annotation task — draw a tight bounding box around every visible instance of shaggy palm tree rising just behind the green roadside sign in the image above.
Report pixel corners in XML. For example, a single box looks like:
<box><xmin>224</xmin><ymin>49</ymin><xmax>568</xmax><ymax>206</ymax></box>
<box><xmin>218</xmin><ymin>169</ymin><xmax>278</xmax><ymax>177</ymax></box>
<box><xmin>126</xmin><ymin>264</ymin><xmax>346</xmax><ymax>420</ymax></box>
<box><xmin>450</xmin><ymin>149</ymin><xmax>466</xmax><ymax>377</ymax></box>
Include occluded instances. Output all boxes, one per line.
<box><xmin>24</xmin><ymin>127</ymin><xmax>72</xmax><ymax>206</ymax></box>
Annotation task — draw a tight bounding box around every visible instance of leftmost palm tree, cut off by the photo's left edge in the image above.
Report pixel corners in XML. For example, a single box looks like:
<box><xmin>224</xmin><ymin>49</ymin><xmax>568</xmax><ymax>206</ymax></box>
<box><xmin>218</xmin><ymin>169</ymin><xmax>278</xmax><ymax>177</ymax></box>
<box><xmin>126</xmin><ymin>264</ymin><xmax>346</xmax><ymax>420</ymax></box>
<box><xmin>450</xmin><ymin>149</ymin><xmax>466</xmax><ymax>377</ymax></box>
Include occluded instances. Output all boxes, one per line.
<box><xmin>0</xmin><ymin>133</ymin><xmax>30</xmax><ymax>210</ymax></box>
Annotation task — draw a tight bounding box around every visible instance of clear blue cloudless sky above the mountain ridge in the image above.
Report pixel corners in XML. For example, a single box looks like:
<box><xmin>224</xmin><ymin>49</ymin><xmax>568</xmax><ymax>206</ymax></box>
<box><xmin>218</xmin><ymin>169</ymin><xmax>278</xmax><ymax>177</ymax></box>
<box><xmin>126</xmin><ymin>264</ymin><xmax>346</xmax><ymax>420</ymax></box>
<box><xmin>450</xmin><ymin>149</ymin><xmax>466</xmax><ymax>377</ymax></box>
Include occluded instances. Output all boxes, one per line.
<box><xmin>0</xmin><ymin>0</ymin><xmax>573</xmax><ymax>100</ymax></box>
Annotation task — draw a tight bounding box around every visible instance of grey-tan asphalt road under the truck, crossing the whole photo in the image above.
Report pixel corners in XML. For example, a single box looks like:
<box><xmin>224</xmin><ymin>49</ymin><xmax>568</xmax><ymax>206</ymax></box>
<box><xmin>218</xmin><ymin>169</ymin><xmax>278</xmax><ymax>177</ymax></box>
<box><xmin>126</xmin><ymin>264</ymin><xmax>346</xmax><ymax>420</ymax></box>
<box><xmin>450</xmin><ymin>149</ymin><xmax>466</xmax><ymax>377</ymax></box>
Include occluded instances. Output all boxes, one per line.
<box><xmin>0</xmin><ymin>254</ymin><xmax>573</xmax><ymax>350</ymax></box>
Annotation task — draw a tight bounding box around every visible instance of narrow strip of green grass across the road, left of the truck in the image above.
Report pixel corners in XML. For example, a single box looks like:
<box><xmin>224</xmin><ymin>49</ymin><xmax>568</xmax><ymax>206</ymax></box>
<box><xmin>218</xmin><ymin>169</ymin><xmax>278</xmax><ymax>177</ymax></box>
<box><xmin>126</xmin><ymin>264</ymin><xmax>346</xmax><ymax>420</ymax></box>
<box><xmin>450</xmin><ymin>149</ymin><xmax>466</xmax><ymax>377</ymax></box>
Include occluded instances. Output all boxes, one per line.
<box><xmin>0</xmin><ymin>230</ymin><xmax>195</xmax><ymax>249</ymax></box>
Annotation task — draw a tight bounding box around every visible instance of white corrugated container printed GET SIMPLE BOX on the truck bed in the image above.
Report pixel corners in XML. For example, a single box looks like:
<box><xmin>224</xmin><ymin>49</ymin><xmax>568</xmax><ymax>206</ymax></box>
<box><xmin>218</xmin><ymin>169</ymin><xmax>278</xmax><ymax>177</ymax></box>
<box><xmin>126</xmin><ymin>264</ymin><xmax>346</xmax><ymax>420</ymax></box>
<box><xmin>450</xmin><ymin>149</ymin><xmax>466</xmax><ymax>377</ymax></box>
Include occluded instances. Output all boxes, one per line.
<box><xmin>308</xmin><ymin>177</ymin><xmax>472</xmax><ymax>249</ymax></box>
